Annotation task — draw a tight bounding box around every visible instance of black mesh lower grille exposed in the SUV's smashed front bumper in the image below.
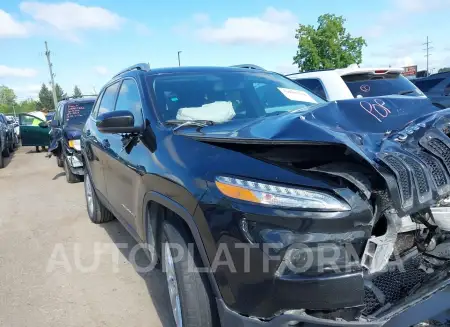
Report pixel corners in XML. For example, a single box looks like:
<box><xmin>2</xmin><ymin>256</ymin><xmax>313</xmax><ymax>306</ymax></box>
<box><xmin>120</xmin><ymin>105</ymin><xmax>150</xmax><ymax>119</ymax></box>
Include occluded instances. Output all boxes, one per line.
<box><xmin>363</xmin><ymin>256</ymin><xmax>427</xmax><ymax>315</ymax></box>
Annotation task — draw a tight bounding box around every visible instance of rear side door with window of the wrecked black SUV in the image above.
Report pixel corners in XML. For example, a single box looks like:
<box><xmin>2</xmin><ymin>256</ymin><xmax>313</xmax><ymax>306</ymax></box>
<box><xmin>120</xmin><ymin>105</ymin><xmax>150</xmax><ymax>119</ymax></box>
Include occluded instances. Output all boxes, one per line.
<box><xmin>82</xmin><ymin>82</ymin><xmax>119</xmax><ymax>202</ymax></box>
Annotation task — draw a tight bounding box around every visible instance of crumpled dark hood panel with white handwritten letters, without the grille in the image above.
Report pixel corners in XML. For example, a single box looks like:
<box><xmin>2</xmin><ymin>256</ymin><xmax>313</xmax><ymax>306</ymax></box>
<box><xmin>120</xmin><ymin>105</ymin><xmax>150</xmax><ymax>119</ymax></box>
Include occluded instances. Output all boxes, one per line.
<box><xmin>176</xmin><ymin>96</ymin><xmax>442</xmax><ymax>159</ymax></box>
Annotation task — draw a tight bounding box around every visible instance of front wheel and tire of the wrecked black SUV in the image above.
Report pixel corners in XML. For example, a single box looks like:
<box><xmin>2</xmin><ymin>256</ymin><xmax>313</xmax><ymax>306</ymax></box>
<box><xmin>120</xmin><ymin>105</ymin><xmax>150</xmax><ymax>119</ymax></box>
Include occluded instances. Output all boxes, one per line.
<box><xmin>161</xmin><ymin>220</ymin><xmax>218</xmax><ymax>327</ymax></box>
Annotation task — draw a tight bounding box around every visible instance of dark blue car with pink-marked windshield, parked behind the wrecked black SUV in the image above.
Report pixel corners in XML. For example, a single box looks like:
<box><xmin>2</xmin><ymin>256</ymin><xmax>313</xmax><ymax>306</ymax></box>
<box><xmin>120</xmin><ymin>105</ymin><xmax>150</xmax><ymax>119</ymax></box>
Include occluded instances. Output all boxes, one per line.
<box><xmin>49</xmin><ymin>96</ymin><xmax>96</xmax><ymax>183</ymax></box>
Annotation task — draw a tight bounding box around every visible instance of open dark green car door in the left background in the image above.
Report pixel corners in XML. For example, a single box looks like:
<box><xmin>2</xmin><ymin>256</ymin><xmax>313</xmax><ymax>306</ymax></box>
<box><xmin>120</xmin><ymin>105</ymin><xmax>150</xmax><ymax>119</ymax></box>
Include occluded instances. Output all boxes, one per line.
<box><xmin>19</xmin><ymin>114</ymin><xmax>50</xmax><ymax>146</ymax></box>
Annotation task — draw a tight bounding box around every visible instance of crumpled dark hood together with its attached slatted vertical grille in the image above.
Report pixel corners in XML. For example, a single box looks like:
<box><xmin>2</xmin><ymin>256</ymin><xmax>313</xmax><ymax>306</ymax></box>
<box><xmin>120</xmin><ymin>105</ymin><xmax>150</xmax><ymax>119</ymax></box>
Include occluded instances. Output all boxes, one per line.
<box><xmin>175</xmin><ymin>96</ymin><xmax>450</xmax><ymax>214</ymax></box>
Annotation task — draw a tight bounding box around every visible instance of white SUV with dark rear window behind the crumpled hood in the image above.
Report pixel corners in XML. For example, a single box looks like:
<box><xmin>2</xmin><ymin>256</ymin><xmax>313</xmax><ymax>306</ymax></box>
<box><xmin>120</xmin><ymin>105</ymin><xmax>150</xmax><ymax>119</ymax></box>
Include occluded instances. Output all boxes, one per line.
<box><xmin>286</xmin><ymin>66</ymin><xmax>425</xmax><ymax>101</ymax></box>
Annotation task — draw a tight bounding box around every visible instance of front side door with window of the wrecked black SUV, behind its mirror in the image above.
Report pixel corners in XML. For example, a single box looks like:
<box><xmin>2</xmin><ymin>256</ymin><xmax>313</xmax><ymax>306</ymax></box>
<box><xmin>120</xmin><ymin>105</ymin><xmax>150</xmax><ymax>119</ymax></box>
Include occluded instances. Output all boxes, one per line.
<box><xmin>105</xmin><ymin>78</ymin><xmax>148</xmax><ymax>230</ymax></box>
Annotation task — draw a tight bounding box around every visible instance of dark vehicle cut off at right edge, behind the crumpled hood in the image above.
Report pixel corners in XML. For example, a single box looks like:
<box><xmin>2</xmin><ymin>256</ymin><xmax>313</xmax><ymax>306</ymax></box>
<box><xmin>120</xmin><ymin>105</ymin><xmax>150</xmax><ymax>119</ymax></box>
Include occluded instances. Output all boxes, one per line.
<box><xmin>412</xmin><ymin>72</ymin><xmax>450</xmax><ymax>109</ymax></box>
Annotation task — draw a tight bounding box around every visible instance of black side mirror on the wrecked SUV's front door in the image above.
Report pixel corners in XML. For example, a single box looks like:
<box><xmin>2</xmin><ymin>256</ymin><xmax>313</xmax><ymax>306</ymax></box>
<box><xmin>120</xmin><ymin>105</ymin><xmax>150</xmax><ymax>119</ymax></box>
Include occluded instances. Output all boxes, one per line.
<box><xmin>96</xmin><ymin>110</ymin><xmax>142</xmax><ymax>134</ymax></box>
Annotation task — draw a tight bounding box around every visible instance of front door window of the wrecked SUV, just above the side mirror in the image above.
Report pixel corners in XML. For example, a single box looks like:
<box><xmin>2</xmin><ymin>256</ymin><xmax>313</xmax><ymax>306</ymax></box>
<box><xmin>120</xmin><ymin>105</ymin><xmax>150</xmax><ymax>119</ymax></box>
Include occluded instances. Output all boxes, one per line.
<box><xmin>116</xmin><ymin>79</ymin><xmax>143</xmax><ymax>126</ymax></box>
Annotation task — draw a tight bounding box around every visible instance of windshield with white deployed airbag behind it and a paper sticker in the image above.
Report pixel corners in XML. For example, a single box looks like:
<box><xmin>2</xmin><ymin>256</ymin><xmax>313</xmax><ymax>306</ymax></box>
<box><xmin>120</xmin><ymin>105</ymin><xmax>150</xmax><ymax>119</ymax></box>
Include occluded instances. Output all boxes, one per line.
<box><xmin>149</xmin><ymin>71</ymin><xmax>325</xmax><ymax>122</ymax></box>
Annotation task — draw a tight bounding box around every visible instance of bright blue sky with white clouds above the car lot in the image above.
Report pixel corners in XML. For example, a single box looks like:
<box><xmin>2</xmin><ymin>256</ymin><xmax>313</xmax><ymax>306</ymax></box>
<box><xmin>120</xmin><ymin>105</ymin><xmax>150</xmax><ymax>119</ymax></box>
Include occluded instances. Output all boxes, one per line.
<box><xmin>0</xmin><ymin>0</ymin><xmax>450</xmax><ymax>99</ymax></box>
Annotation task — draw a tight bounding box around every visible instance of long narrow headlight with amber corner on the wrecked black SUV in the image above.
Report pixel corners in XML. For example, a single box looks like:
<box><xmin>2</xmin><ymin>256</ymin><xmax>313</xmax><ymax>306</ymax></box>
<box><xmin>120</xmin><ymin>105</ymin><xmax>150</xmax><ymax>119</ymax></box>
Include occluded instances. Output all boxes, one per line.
<box><xmin>216</xmin><ymin>176</ymin><xmax>351</xmax><ymax>211</ymax></box>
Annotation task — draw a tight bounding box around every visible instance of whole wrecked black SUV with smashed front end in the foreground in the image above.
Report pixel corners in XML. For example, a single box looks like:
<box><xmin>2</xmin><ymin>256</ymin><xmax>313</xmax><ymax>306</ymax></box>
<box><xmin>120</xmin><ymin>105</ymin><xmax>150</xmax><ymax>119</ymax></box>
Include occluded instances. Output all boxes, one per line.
<box><xmin>81</xmin><ymin>64</ymin><xmax>450</xmax><ymax>327</ymax></box>
